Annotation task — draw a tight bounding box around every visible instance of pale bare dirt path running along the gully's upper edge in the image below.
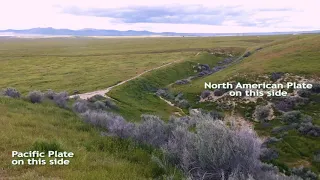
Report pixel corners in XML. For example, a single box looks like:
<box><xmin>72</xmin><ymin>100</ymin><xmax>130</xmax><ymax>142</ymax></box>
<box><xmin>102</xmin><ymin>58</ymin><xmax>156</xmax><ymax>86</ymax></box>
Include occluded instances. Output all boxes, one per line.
<box><xmin>69</xmin><ymin>59</ymin><xmax>182</xmax><ymax>99</ymax></box>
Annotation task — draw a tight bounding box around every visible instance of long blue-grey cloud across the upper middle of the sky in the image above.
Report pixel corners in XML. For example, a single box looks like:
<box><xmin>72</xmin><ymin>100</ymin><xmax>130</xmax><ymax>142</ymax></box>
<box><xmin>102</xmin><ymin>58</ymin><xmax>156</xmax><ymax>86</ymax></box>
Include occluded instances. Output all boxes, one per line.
<box><xmin>62</xmin><ymin>5</ymin><xmax>241</xmax><ymax>25</ymax></box>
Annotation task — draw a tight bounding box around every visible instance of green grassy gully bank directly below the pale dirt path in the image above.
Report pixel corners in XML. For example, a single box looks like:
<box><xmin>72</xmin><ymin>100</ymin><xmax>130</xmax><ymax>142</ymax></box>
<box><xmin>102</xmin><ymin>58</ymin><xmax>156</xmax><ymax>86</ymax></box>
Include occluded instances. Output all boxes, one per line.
<box><xmin>108</xmin><ymin>53</ymin><xmax>235</xmax><ymax>120</ymax></box>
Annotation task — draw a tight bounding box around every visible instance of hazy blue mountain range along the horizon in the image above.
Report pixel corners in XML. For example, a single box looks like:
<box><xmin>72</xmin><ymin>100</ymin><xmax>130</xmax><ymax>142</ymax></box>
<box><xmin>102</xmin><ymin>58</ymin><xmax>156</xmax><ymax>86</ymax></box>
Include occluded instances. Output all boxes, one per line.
<box><xmin>0</xmin><ymin>28</ymin><xmax>320</xmax><ymax>36</ymax></box>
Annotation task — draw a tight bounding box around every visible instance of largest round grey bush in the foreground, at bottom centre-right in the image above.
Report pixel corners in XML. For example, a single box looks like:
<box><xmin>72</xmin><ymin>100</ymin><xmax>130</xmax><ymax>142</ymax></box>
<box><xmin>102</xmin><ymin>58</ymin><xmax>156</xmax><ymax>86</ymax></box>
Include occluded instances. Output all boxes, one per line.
<box><xmin>165</xmin><ymin>120</ymin><xmax>260</xmax><ymax>179</ymax></box>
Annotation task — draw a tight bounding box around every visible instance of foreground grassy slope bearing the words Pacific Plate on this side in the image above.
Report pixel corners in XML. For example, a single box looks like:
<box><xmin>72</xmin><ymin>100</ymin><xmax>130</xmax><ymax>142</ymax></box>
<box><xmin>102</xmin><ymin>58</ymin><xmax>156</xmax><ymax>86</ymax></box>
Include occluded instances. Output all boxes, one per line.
<box><xmin>0</xmin><ymin>98</ymin><xmax>180</xmax><ymax>180</ymax></box>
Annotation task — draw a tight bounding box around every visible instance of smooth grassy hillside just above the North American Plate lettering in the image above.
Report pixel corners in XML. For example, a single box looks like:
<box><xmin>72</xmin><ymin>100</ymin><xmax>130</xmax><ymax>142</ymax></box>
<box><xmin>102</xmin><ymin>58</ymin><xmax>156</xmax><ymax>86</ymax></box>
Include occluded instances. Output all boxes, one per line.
<box><xmin>175</xmin><ymin>35</ymin><xmax>320</xmax><ymax>93</ymax></box>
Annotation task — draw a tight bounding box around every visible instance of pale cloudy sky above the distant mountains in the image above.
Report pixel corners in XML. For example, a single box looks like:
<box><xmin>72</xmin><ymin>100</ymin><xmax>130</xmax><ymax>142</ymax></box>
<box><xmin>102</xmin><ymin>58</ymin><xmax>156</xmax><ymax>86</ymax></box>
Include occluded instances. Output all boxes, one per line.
<box><xmin>0</xmin><ymin>0</ymin><xmax>320</xmax><ymax>33</ymax></box>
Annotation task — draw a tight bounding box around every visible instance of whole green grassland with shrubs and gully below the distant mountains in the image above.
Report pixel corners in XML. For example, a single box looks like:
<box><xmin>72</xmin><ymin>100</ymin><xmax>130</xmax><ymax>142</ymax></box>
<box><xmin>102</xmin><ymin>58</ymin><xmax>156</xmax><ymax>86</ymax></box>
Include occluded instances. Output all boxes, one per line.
<box><xmin>0</xmin><ymin>35</ymin><xmax>320</xmax><ymax>180</ymax></box>
